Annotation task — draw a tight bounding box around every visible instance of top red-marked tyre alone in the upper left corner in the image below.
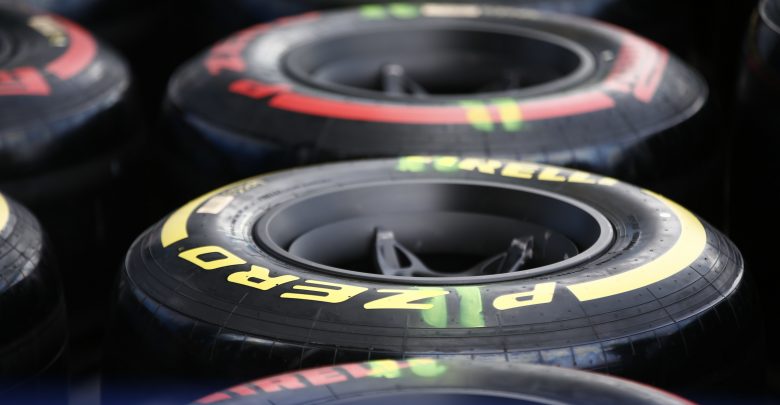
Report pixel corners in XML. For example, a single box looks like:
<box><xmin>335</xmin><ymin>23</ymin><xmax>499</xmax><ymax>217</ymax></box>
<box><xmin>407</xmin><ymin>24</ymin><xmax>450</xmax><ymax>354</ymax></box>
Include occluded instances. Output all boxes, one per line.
<box><xmin>0</xmin><ymin>5</ymin><xmax>136</xmax><ymax>180</ymax></box>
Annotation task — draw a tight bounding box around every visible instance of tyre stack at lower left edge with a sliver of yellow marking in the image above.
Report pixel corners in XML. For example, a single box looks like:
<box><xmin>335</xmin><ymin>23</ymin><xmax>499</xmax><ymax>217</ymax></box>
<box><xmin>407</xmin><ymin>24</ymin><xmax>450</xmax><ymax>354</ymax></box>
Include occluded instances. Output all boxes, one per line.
<box><xmin>0</xmin><ymin>194</ymin><xmax>67</xmax><ymax>403</ymax></box>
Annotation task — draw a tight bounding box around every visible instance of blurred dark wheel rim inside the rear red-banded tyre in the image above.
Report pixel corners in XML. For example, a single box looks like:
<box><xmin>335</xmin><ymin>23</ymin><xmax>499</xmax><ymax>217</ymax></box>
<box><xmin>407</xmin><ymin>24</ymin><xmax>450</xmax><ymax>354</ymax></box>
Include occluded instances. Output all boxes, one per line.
<box><xmin>282</xmin><ymin>22</ymin><xmax>595</xmax><ymax>100</ymax></box>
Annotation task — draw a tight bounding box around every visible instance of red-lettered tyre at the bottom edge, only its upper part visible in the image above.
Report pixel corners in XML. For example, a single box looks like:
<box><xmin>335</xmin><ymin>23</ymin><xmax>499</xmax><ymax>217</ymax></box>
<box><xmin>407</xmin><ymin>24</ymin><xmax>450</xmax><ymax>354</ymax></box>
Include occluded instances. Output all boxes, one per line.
<box><xmin>193</xmin><ymin>358</ymin><xmax>691</xmax><ymax>405</ymax></box>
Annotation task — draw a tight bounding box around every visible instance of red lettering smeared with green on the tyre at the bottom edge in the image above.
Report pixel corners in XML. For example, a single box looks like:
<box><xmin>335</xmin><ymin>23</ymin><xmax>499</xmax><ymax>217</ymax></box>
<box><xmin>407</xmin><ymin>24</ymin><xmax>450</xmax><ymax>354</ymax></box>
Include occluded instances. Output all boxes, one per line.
<box><xmin>197</xmin><ymin>358</ymin><xmax>447</xmax><ymax>404</ymax></box>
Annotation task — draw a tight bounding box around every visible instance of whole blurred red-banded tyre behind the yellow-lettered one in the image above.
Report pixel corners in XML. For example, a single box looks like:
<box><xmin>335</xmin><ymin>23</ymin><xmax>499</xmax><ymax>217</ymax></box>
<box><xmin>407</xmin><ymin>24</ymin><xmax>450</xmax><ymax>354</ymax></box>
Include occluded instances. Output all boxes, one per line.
<box><xmin>164</xmin><ymin>5</ymin><xmax>724</xmax><ymax>221</ymax></box>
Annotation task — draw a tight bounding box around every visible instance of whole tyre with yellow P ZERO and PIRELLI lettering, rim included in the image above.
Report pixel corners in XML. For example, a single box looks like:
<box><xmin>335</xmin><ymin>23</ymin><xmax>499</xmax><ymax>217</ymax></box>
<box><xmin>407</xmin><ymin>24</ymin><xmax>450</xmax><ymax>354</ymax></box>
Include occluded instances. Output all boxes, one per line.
<box><xmin>103</xmin><ymin>156</ymin><xmax>760</xmax><ymax>398</ymax></box>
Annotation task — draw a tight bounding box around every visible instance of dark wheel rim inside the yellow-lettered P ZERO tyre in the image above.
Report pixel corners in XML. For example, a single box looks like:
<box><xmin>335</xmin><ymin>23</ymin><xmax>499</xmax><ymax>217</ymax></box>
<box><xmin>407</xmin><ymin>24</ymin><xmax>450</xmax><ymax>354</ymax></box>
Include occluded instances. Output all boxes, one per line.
<box><xmin>254</xmin><ymin>181</ymin><xmax>614</xmax><ymax>284</ymax></box>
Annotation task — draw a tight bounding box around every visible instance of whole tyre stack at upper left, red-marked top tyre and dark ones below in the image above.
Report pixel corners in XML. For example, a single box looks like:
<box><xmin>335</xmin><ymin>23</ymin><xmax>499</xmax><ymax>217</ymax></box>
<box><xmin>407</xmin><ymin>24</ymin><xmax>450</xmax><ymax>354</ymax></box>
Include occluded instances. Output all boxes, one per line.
<box><xmin>0</xmin><ymin>4</ymin><xmax>143</xmax><ymax>376</ymax></box>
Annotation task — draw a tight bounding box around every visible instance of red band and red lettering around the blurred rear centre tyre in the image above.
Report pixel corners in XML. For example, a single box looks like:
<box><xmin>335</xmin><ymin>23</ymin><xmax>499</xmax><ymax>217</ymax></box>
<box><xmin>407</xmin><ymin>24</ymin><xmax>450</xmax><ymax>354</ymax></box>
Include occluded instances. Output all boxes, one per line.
<box><xmin>213</xmin><ymin>14</ymin><xmax>669</xmax><ymax>125</ymax></box>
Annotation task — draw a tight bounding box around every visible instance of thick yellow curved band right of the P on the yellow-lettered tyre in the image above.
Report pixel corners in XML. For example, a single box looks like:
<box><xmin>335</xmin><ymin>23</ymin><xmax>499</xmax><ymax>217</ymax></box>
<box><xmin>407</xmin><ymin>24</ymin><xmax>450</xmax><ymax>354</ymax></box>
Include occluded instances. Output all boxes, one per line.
<box><xmin>568</xmin><ymin>190</ymin><xmax>707</xmax><ymax>301</ymax></box>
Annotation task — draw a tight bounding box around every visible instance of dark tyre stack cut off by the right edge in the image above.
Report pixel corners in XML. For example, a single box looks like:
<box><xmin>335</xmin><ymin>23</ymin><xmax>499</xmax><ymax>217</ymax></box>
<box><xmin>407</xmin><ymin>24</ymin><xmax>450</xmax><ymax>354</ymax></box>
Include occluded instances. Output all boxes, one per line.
<box><xmin>731</xmin><ymin>0</ymin><xmax>780</xmax><ymax>389</ymax></box>
